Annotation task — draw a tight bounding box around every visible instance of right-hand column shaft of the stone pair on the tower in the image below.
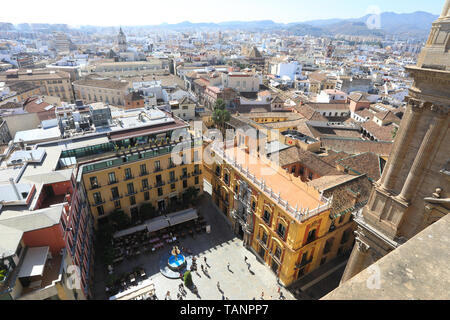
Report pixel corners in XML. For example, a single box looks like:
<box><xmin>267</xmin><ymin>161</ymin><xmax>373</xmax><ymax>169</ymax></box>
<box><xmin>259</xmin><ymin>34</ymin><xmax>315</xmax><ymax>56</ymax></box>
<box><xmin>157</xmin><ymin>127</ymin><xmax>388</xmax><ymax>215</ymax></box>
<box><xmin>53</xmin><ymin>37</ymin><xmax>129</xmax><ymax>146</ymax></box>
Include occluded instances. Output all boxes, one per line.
<box><xmin>398</xmin><ymin>106</ymin><xmax>446</xmax><ymax>202</ymax></box>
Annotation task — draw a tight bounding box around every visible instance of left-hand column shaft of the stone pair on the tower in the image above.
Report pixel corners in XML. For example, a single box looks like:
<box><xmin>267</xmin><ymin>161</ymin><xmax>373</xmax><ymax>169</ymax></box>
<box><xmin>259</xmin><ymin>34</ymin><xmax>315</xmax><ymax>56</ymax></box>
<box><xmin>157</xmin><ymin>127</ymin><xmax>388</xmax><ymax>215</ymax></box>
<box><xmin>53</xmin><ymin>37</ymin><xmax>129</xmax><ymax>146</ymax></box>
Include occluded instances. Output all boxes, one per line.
<box><xmin>380</xmin><ymin>99</ymin><xmax>423</xmax><ymax>191</ymax></box>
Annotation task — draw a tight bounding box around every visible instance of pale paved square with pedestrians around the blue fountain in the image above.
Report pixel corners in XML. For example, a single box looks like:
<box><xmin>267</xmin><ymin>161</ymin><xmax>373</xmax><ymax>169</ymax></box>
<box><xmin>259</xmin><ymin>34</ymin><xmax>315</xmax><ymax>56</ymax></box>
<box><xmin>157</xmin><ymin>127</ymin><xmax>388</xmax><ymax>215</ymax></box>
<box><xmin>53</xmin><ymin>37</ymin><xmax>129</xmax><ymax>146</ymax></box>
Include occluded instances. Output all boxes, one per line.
<box><xmin>94</xmin><ymin>195</ymin><xmax>294</xmax><ymax>300</ymax></box>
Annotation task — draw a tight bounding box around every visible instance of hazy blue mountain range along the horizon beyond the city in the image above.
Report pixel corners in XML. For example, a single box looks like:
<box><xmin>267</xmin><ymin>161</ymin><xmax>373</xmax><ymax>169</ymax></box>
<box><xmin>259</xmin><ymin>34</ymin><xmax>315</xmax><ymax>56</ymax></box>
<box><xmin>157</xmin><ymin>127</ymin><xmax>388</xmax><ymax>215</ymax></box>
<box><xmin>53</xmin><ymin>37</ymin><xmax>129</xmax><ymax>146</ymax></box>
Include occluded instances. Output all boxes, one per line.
<box><xmin>0</xmin><ymin>11</ymin><xmax>438</xmax><ymax>38</ymax></box>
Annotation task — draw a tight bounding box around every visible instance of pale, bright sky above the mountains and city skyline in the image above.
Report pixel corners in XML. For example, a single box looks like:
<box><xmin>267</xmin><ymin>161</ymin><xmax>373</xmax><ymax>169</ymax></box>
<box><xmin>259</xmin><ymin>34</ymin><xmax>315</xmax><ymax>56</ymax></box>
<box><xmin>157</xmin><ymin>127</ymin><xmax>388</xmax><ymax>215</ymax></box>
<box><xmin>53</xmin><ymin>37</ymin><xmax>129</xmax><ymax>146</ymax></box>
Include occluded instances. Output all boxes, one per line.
<box><xmin>0</xmin><ymin>0</ymin><xmax>445</xmax><ymax>26</ymax></box>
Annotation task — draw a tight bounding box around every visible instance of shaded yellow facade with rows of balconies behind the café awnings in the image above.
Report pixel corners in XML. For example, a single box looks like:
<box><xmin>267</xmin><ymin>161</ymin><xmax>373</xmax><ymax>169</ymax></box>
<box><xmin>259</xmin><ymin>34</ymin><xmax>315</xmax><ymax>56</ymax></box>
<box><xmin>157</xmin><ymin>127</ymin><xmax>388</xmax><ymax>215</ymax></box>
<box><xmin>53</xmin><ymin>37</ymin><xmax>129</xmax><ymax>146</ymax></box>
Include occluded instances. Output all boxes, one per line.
<box><xmin>82</xmin><ymin>141</ymin><xmax>203</xmax><ymax>227</ymax></box>
